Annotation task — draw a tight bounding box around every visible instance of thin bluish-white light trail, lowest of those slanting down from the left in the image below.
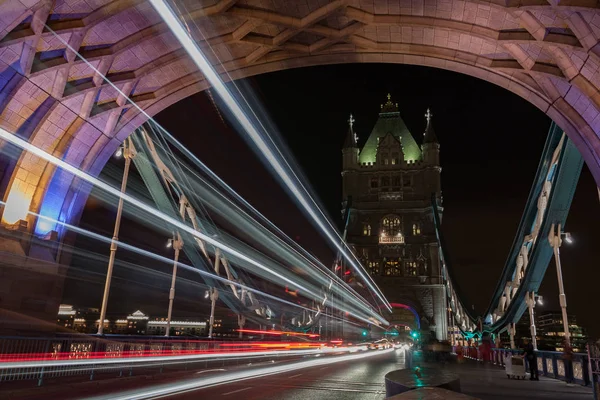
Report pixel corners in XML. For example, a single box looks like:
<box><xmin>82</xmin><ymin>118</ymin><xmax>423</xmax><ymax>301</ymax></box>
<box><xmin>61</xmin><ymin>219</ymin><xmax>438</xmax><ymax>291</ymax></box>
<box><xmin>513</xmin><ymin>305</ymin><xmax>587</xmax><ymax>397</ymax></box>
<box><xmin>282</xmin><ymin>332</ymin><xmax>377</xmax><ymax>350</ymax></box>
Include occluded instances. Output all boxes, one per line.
<box><xmin>0</xmin><ymin>198</ymin><xmax>387</xmax><ymax>325</ymax></box>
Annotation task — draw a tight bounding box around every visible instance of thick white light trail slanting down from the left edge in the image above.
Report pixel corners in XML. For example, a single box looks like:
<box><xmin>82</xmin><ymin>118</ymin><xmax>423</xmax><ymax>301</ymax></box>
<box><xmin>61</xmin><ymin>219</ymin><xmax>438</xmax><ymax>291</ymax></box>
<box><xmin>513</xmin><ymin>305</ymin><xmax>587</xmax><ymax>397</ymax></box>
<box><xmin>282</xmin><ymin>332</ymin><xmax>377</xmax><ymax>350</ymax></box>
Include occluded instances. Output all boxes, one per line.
<box><xmin>0</xmin><ymin>128</ymin><xmax>387</xmax><ymax>324</ymax></box>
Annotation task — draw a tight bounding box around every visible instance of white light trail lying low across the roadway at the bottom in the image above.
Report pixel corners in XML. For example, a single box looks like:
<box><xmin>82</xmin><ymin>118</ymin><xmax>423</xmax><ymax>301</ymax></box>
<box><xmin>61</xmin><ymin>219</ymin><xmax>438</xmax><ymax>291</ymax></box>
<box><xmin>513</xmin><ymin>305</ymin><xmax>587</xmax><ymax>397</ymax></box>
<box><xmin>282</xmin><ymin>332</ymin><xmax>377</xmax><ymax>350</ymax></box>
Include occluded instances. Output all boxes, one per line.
<box><xmin>83</xmin><ymin>349</ymin><xmax>395</xmax><ymax>400</ymax></box>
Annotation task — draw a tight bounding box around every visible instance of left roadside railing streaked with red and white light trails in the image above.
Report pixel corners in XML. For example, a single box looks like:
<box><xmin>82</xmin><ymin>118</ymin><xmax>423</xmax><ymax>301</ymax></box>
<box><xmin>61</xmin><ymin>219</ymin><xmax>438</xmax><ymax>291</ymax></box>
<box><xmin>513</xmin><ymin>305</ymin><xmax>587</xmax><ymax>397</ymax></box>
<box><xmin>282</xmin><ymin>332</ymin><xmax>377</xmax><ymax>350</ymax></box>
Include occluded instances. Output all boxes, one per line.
<box><xmin>0</xmin><ymin>335</ymin><xmax>320</xmax><ymax>386</ymax></box>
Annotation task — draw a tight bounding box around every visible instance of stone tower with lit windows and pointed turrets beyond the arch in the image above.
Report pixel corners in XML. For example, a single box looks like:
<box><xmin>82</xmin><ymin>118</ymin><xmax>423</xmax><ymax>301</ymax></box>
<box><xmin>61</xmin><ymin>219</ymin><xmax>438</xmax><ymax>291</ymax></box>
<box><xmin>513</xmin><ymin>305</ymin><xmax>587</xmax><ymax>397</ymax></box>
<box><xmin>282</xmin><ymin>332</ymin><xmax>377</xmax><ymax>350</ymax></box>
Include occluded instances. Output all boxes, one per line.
<box><xmin>342</xmin><ymin>95</ymin><xmax>448</xmax><ymax>340</ymax></box>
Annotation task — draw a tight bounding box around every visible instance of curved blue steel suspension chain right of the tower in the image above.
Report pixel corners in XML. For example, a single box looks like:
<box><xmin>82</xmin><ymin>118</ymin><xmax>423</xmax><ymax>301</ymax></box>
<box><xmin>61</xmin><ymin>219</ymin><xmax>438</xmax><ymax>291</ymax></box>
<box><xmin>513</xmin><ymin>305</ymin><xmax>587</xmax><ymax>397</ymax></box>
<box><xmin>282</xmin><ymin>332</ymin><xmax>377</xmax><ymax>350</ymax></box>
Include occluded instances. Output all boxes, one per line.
<box><xmin>432</xmin><ymin>124</ymin><xmax>583</xmax><ymax>337</ymax></box>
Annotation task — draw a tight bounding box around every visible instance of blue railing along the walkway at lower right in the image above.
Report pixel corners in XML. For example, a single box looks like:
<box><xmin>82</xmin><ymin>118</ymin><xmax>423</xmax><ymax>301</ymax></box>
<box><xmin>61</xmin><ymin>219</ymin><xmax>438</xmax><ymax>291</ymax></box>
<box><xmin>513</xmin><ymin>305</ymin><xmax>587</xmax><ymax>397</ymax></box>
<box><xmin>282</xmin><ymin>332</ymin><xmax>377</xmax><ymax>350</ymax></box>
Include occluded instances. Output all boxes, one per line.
<box><xmin>453</xmin><ymin>346</ymin><xmax>590</xmax><ymax>386</ymax></box>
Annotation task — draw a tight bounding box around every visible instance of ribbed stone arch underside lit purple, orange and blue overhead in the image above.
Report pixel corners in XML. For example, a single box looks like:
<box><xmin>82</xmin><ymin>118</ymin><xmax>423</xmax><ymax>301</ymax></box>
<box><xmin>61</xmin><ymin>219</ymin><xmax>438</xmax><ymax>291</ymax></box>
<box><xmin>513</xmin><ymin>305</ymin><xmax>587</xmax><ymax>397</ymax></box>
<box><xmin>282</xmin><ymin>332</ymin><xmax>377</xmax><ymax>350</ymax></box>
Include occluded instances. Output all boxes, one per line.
<box><xmin>0</xmin><ymin>0</ymin><xmax>600</xmax><ymax>234</ymax></box>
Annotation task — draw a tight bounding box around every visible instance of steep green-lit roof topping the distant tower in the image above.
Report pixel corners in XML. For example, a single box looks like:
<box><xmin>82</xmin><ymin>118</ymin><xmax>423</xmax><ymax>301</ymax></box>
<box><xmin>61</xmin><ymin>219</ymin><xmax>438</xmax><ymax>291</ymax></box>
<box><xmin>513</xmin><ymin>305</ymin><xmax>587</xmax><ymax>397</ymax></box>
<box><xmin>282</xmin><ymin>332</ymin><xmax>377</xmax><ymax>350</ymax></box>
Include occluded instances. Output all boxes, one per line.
<box><xmin>358</xmin><ymin>94</ymin><xmax>422</xmax><ymax>163</ymax></box>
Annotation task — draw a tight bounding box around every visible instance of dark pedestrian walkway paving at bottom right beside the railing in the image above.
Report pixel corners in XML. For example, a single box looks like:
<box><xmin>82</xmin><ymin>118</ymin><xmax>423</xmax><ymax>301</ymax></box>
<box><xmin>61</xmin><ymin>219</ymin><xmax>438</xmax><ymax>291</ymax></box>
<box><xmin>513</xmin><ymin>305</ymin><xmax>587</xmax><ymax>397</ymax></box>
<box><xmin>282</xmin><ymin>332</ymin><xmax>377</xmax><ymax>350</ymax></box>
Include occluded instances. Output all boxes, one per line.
<box><xmin>413</xmin><ymin>357</ymin><xmax>593</xmax><ymax>400</ymax></box>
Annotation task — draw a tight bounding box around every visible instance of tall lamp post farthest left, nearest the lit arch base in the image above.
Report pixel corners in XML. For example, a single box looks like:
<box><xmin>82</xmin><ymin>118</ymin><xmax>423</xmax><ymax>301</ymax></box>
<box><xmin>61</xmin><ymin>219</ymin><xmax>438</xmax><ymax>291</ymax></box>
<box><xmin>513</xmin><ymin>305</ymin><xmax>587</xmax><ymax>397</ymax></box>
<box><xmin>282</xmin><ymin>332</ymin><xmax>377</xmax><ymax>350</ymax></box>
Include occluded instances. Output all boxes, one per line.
<box><xmin>98</xmin><ymin>138</ymin><xmax>136</xmax><ymax>335</ymax></box>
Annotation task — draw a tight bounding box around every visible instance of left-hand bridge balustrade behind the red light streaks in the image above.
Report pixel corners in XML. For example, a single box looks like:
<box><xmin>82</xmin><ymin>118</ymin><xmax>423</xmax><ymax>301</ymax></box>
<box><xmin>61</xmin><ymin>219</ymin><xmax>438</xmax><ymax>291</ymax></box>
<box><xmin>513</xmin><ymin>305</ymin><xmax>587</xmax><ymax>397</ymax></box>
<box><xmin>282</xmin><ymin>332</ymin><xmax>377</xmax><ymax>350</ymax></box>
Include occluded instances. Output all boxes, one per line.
<box><xmin>0</xmin><ymin>335</ymin><xmax>298</xmax><ymax>385</ymax></box>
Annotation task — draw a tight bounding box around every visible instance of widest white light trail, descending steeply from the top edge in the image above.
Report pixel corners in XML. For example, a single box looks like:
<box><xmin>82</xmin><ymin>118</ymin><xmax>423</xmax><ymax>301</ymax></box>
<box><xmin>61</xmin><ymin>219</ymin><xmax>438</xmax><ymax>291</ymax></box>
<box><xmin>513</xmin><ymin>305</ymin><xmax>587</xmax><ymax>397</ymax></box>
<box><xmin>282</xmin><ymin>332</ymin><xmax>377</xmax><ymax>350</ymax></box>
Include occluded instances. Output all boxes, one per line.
<box><xmin>150</xmin><ymin>0</ymin><xmax>392</xmax><ymax>311</ymax></box>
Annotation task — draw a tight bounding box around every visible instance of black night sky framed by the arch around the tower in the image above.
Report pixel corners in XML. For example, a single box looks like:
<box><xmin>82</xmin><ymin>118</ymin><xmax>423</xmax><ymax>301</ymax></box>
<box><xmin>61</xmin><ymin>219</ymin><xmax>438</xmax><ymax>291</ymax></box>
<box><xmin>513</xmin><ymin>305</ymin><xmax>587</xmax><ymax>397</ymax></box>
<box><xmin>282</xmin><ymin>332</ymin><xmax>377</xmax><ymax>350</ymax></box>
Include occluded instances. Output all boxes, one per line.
<box><xmin>65</xmin><ymin>64</ymin><xmax>600</xmax><ymax>337</ymax></box>
